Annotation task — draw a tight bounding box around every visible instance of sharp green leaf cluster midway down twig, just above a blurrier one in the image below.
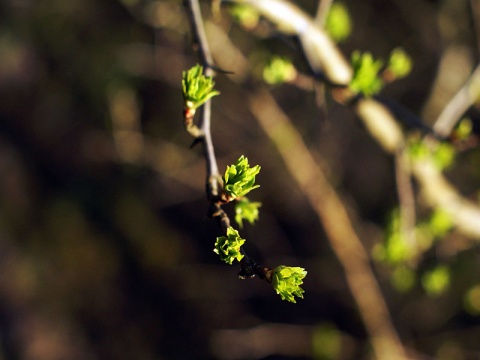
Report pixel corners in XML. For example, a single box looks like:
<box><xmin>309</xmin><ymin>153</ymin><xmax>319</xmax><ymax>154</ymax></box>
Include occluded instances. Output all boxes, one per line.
<box><xmin>223</xmin><ymin>155</ymin><xmax>260</xmax><ymax>201</ymax></box>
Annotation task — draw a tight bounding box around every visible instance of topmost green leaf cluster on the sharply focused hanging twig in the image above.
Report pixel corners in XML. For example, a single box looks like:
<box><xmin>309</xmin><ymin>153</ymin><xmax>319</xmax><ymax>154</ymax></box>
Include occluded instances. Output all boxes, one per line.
<box><xmin>182</xmin><ymin>64</ymin><xmax>220</xmax><ymax>110</ymax></box>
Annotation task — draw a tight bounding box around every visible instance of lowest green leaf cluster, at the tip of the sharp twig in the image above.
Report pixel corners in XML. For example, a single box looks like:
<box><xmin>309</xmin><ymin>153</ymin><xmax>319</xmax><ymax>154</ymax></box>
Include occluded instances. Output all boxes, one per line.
<box><xmin>272</xmin><ymin>265</ymin><xmax>307</xmax><ymax>303</ymax></box>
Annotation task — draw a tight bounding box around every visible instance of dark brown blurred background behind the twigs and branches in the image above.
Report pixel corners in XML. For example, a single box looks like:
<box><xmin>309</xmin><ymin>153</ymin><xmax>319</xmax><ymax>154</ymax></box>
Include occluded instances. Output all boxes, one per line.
<box><xmin>0</xmin><ymin>0</ymin><xmax>480</xmax><ymax>360</ymax></box>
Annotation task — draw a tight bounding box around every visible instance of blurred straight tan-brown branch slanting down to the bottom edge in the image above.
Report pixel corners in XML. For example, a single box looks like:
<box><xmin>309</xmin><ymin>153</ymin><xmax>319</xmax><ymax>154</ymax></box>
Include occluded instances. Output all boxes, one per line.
<box><xmin>250</xmin><ymin>91</ymin><xmax>406</xmax><ymax>360</ymax></box>
